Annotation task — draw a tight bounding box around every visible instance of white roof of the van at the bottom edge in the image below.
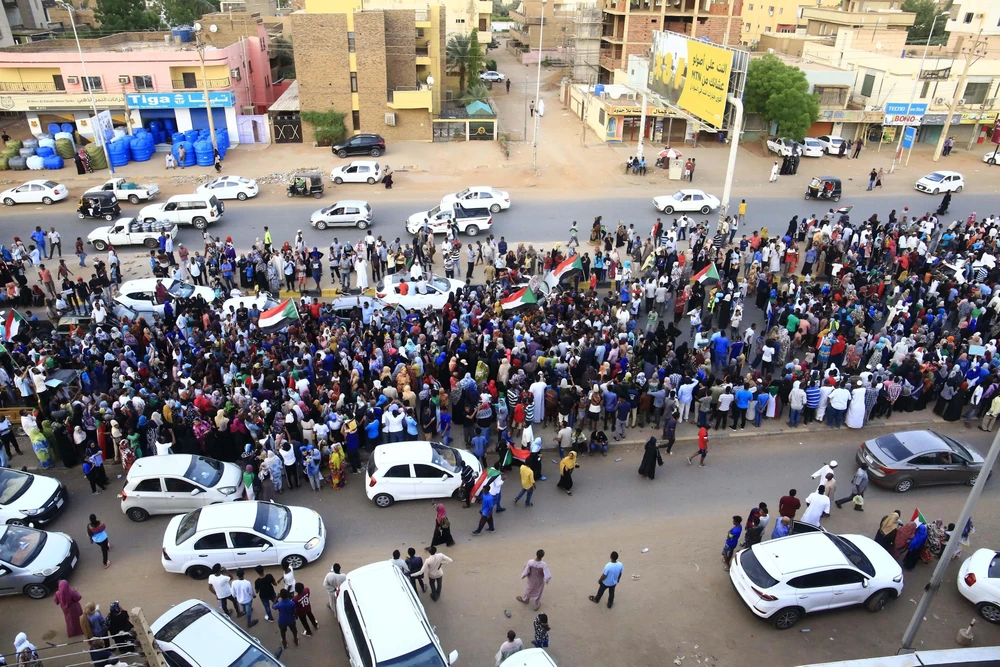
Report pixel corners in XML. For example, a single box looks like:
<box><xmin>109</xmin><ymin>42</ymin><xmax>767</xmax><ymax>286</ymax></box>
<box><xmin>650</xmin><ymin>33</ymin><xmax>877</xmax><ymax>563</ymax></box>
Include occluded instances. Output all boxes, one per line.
<box><xmin>347</xmin><ymin>561</ymin><xmax>433</xmax><ymax>662</ymax></box>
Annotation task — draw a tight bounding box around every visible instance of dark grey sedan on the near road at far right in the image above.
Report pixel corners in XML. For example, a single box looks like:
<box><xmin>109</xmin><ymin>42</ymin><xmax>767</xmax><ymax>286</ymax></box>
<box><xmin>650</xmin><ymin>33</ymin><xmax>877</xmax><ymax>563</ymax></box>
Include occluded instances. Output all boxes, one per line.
<box><xmin>855</xmin><ymin>431</ymin><xmax>983</xmax><ymax>493</ymax></box>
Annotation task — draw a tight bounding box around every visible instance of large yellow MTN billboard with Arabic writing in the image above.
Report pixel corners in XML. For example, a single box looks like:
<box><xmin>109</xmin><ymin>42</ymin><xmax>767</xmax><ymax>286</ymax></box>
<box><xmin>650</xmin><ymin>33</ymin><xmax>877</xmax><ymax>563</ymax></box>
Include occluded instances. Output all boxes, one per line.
<box><xmin>648</xmin><ymin>31</ymin><xmax>733</xmax><ymax>128</ymax></box>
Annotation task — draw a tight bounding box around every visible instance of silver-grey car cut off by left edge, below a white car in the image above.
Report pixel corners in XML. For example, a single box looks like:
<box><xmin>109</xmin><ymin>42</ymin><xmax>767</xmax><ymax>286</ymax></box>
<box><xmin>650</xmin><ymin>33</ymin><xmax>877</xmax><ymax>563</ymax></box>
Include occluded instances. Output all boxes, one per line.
<box><xmin>0</xmin><ymin>524</ymin><xmax>80</xmax><ymax>600</ymax></box>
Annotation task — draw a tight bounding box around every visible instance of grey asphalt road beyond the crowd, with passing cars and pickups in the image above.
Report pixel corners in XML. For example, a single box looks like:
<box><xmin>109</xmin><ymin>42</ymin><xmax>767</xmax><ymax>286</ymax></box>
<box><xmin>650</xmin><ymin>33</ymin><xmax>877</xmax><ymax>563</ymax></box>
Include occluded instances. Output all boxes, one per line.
<box><xmin>2</xmin><ymin>192</ymin><xmax>997</xmax><ymax>256</ymax></box>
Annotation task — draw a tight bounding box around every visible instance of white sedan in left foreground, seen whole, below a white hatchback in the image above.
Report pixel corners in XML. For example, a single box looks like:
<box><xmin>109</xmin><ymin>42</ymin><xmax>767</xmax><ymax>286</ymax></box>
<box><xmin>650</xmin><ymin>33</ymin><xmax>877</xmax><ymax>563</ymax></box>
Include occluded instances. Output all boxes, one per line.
<box><xmin>160</xmin><ymin>500</ymin><xmax>326</xmax><ymax>579</ymax></box>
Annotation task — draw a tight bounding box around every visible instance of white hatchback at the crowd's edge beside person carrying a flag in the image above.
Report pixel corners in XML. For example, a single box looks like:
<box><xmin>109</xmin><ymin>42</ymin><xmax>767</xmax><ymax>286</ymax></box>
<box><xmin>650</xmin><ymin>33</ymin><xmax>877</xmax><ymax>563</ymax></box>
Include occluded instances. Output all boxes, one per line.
<box><xmin>365</xmin><ymin>440</ymin><xmax>483</xmax><ymax>507</ymax></box>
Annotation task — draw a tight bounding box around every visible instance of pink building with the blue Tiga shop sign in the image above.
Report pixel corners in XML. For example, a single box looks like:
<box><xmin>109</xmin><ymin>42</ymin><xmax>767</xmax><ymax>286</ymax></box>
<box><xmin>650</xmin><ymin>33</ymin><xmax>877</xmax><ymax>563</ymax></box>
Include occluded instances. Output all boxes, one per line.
<box><xmin>0</xmin><ymin>19</ymin><xmax>273</xmax><ymax>144</ymax></box>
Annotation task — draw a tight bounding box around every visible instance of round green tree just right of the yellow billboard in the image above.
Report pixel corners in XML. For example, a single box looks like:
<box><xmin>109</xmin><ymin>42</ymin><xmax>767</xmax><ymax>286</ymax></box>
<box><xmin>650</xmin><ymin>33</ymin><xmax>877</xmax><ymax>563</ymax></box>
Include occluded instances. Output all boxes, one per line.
<box><xmin>743</xmin><ymin>54</ymin><xmax>819</xmax><ymax>141</ymax></box>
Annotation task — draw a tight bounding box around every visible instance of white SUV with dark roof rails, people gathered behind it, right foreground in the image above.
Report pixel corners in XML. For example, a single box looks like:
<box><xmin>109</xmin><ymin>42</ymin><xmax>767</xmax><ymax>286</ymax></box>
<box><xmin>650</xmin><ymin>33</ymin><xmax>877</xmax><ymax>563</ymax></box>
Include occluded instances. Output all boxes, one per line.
<box><xmin>729</xmin><ymin>531</ymin><xmax>903</xmax><ymax>630</ymax></box>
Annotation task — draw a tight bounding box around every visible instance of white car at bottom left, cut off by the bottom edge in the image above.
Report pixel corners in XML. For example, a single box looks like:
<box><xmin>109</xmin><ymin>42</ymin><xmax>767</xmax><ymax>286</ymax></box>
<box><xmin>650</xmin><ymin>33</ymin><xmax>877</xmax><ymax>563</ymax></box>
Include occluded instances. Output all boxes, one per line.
<box><xmin>150</xmin><ymin>600</ymin><xmax>284</xmax><ymax>667</ymax></box>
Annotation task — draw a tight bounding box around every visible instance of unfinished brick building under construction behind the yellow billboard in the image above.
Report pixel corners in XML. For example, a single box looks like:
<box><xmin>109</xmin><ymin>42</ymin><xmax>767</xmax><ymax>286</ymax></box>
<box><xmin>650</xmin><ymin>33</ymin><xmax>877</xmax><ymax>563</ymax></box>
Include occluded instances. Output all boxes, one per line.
<box><xmin>599</xmin><ymin>0</ymin><xmax>744</xmax><ymax>83</ymax></box>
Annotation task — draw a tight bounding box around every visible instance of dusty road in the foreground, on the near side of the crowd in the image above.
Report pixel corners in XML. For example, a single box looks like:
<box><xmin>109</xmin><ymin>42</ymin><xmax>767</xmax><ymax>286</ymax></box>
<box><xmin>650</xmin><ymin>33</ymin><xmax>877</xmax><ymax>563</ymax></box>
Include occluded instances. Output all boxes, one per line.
<box><xmin>0</xmin><ymin>424</ymin><xmax>1000</xmax><ymax>667</ymax></box>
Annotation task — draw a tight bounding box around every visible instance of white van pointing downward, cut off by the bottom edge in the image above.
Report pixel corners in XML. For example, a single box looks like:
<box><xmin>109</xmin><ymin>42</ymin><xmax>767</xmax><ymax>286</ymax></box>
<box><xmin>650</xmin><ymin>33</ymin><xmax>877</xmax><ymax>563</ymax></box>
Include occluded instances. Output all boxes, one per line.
<box><xmin>337</xmin><ymin>561</ymin><xmax>458</xmax><ymax>667</ymax></box>
